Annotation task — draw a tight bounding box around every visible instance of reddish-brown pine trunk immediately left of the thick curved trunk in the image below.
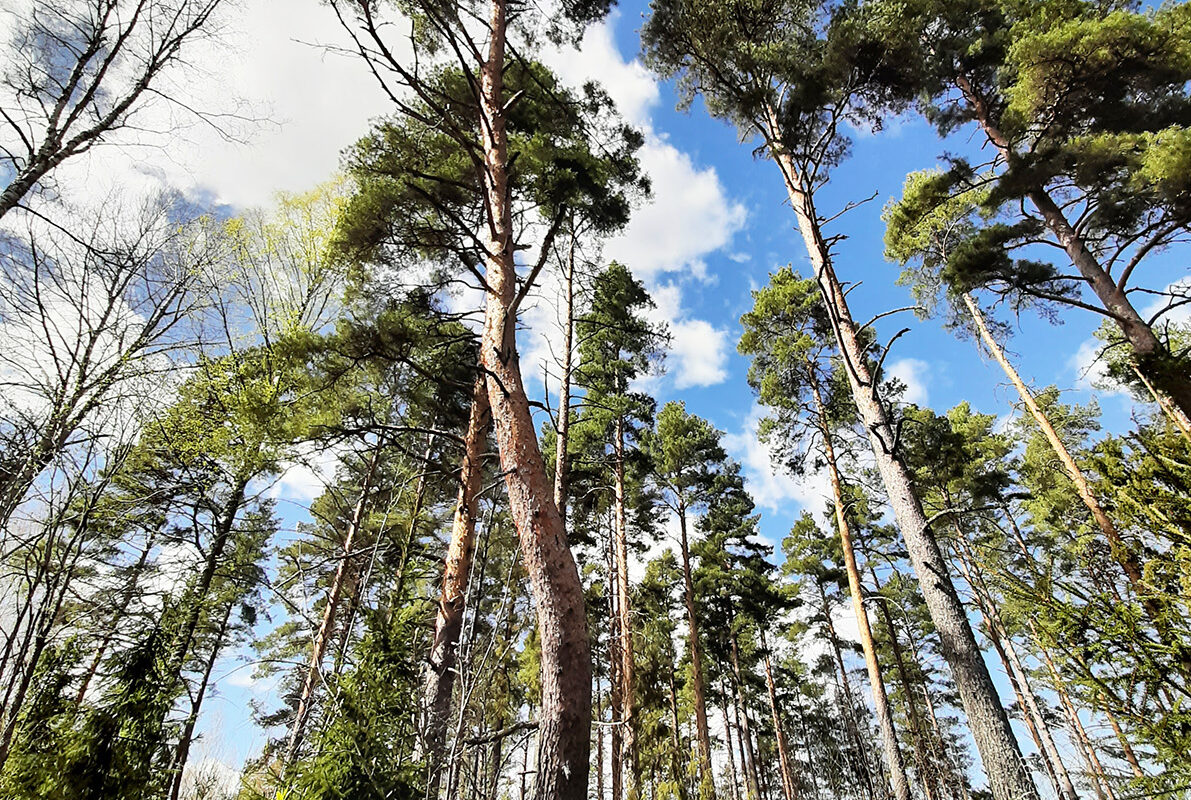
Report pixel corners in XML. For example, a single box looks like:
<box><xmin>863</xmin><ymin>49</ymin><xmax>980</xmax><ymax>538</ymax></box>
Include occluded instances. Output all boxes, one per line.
<box><xmin>425</xmin><ymin>377</ymin><xmax>488</xmax><ymax>800</ymax></box>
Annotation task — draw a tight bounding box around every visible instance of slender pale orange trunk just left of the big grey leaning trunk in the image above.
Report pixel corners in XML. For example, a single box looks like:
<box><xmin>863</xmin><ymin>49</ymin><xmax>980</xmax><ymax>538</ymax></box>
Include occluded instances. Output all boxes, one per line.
<box><xmin>811</xmin><ymin>381</ymin><xmax>910</xmax><ymax>800</ymax></box>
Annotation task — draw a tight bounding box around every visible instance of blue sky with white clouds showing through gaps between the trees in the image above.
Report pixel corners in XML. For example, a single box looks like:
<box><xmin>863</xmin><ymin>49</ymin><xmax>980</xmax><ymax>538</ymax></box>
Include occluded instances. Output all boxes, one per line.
<box><xmin>18</xmin><ymin>0</ymin><xmax>1185</xmax><ymax>790</ymax></box>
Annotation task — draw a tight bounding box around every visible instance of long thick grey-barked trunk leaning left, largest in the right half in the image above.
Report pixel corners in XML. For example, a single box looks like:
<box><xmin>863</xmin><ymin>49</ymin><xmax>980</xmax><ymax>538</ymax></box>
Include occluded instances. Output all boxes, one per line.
<box><xmin>768</xmin><ymin>108</ymin><xmax>1039</xmax><ymax>800</ymax></box>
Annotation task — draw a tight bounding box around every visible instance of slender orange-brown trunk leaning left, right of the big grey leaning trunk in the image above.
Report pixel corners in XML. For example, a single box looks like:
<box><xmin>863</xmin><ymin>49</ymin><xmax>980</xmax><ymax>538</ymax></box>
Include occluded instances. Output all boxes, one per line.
<box><xmin>964</xmin><ymin>294</ymin><xmax>1177</xmax><ymax>643</ymax></box>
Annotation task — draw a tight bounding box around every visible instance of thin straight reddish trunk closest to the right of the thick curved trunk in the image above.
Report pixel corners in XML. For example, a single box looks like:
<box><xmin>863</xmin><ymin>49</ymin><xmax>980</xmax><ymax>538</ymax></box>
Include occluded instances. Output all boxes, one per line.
<box><xmin>613</xmin><ymin>411</ymin><xmax>640</xmax><ymax>800</ymax></box>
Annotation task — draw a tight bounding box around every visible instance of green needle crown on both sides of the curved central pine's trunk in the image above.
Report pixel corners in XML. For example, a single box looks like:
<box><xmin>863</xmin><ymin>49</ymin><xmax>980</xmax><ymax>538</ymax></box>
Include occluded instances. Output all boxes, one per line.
<box><xmin>338</xmin><ymin>61</ymin><xmax>649</xmax><ymax>278</ymax></box>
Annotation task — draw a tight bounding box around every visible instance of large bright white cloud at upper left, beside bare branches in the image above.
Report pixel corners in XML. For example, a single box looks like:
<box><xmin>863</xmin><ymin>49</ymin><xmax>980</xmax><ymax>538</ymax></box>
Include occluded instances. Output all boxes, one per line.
<box><xmin>46</xmin><ymin>1</ymin><xmax>391</xmax><ymax>207</ymax></box>
